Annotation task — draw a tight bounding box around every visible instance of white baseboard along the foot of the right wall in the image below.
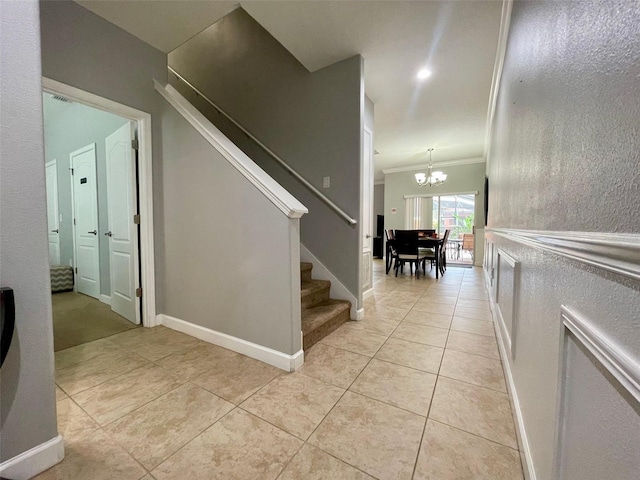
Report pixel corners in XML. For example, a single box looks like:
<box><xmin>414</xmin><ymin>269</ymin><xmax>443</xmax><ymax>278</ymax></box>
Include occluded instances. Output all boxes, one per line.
<box><xmin>485</xmin><ymin>286</ymin><xmax>537</xmax><ymax>480</ymax></box>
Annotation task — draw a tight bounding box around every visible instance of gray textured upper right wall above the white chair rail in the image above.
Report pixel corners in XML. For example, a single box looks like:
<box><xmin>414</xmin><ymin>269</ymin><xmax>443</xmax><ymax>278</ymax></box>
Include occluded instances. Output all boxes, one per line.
<box><xmin>489</xmin><ymin>0</ymin><xmax>640</xmax><ymax>233</ymax></box>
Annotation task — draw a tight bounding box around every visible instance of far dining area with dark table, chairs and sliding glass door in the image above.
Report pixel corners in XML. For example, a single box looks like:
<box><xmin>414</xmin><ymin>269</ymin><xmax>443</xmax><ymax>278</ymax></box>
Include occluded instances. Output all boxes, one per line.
<box><xmin>374</xmin><ymin>158</ymin><xmax>485</xmax><ymax>279</ymax></box>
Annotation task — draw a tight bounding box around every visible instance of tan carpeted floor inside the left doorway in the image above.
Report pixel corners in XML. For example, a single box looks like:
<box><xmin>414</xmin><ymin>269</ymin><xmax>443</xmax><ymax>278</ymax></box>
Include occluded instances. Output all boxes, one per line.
<box><xmin>52</xmin><ymin>292</ymin><xmax>138</xmax><ymax>352</ymax></box>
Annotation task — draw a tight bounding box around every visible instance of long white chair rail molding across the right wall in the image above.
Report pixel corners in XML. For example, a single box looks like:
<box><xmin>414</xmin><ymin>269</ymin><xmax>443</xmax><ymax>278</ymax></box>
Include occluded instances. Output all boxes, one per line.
<box><xmin>485</xmin><ymin>228</ymin><xmax>640</xmax><ymax>280</ymax></box>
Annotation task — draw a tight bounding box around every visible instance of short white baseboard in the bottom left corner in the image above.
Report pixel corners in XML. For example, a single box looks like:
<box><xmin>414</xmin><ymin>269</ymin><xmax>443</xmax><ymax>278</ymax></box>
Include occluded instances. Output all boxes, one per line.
<box><xmin>0</xmin><ymin>435</ymin><xmax>64</xmax><ymax>480</ymax></box>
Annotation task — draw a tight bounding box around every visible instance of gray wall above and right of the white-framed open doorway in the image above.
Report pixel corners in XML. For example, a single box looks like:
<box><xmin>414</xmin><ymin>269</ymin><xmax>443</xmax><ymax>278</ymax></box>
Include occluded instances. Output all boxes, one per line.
<box><xmin>40</xmin><ymin>1</ymin><xmax>167</xmax><ymax>312</ymax></box>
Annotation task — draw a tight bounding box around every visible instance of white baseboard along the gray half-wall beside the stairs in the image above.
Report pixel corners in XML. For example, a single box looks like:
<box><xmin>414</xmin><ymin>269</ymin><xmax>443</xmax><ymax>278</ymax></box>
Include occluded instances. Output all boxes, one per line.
<box><xmin>156</xmin><ymin>313</ymin><xmax>304</xmax><ymax>372</ymax></box>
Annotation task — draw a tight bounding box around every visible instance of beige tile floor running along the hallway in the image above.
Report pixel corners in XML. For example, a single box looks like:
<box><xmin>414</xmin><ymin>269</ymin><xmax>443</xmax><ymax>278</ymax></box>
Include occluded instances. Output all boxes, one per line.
<box><xmin>37</xmin><ymin>261</ymin><xmax>523</xmax><ymax>480</ymax></box>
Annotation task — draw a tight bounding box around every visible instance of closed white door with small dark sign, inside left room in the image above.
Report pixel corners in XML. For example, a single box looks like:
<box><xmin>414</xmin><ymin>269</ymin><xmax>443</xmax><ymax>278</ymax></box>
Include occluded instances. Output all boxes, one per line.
<box><xmin>70</xmin><ymin>143</ymin><xmax>100</xmax><ymax>298</ymax></box>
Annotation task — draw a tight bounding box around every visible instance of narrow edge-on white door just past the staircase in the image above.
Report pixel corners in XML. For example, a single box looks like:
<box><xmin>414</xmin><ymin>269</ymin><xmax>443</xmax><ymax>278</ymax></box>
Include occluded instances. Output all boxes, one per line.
<box><xmin>362</xmin><ymin>127</ymin><xmax>373</xmax><ymax>291</ymax></box>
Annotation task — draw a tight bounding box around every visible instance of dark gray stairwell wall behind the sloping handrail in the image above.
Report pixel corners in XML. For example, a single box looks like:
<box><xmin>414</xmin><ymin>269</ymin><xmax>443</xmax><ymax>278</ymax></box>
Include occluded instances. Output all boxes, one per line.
<box><xmin>169</xmin><ymin>9</ymin><xmax>364</xmax><ymax>297</ymax></box>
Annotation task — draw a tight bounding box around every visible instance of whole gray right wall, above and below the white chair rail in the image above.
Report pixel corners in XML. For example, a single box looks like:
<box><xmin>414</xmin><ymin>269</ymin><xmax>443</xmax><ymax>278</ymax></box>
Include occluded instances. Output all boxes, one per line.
<box><xmin>488</xmin><ymin>0</ymin><xmax>640</xmax><ymax>480</ymax></box>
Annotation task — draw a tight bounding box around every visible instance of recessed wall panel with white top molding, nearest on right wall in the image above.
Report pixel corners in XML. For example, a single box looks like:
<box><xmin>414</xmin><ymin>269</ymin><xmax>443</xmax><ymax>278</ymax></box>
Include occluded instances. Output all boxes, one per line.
<box><xmin>555</xmin><ymin>306</ymin><xmax>640</xmax><ymax>480</ymax></box>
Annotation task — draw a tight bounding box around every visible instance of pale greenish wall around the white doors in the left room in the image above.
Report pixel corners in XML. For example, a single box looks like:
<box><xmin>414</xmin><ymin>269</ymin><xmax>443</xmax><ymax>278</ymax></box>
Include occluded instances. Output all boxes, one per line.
<box><xmin>44</xmin><ymin>93</ymin><xmax>128</xmax><ymax>295</ymax></box>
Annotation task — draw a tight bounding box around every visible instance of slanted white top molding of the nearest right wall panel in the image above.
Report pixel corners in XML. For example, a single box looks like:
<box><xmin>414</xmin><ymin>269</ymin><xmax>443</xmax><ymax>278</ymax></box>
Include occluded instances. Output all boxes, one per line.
<box><xmin>561</xmin><ymin>305</ymin><xmax>640</xmax><ymax>402</ymax></box>
